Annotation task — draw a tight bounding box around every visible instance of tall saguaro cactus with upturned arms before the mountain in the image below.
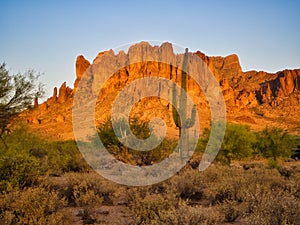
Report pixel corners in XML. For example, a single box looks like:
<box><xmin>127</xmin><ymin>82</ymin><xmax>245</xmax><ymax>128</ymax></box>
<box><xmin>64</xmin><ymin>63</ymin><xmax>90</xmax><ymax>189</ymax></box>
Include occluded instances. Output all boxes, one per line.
<box><xmin>172</xmin><ymin>48</ymin><xmax>196</xmax><ymax>160</ymax></box>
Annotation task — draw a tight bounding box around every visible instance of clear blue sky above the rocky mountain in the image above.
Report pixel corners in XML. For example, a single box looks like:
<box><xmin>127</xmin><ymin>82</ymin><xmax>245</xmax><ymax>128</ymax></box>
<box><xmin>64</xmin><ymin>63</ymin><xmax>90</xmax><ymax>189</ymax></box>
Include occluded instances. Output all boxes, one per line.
<box><xmin>0</xmin><ymin>0</ymin><xmax>300</xmax><ymax>97</ymax></box>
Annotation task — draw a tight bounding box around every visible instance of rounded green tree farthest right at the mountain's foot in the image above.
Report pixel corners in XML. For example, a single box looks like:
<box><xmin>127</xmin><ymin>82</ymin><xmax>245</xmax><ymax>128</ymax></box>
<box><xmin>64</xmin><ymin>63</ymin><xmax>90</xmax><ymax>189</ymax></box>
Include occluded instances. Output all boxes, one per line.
<box><xmin>257</xmin><ymin>127</ymin><xmax>296</xmax><ymax>161</ymax></box>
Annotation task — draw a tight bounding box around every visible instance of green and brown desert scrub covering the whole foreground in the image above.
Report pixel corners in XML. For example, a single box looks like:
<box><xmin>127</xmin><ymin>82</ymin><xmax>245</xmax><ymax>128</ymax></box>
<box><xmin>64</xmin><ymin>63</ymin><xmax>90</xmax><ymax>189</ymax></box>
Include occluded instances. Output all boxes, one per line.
<box><xmin>0</xmin><ymin>121</ymin><xmax>300</xmax><ymax>224</ymax></box>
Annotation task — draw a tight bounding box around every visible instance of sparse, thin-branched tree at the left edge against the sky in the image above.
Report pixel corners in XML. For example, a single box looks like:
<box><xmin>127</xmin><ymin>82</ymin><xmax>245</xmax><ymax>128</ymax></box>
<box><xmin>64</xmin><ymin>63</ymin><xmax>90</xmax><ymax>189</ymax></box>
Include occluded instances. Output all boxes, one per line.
<box><xmin>0</xmin><ymin>63</ymin><xmax>44</xmax><ymax>148</ymax></box>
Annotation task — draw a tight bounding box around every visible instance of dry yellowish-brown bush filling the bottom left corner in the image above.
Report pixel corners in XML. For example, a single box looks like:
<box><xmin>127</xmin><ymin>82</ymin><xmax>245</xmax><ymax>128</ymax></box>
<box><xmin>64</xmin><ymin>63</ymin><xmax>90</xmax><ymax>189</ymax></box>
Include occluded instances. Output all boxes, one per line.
<box><xmin>0</xmin><ymin>187</ymin><xmax>68</xmax><ymax>225</ymax></box>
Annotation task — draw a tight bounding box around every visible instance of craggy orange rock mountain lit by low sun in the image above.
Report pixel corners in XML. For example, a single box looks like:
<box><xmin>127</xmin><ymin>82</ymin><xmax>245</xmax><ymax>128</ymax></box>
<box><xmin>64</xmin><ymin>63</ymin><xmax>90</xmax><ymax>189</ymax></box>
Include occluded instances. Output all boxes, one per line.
<box><xmin>21</xmin><ymin>42</ymin><xmax>300</xmax><ymax>139</ymax></box>
